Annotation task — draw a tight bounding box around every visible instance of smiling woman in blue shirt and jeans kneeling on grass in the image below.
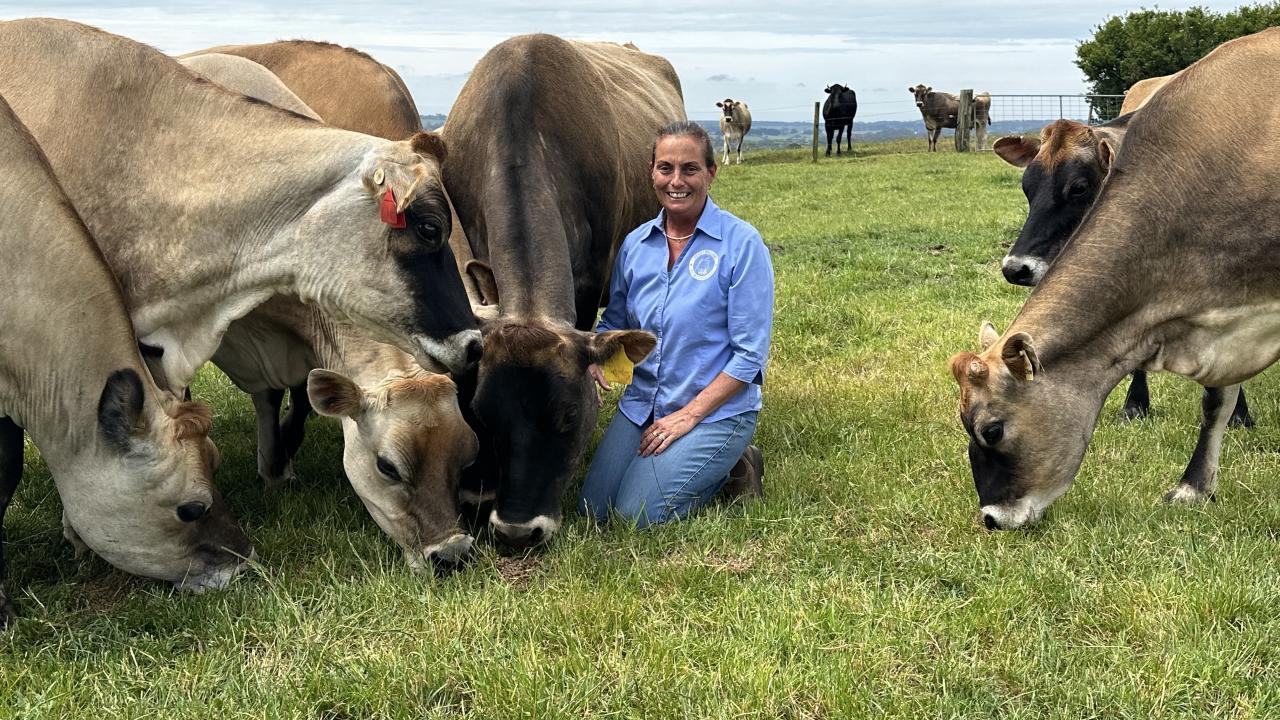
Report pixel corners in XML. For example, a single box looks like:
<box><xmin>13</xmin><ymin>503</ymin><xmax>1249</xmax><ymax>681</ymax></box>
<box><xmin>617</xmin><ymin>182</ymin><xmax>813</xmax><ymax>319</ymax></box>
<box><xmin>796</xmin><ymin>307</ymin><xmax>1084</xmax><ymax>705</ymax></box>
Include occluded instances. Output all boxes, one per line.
<box><xmin>580</xmin><ymin>122</ymin><xmax>773</xmax><ymax>527</ymax></box>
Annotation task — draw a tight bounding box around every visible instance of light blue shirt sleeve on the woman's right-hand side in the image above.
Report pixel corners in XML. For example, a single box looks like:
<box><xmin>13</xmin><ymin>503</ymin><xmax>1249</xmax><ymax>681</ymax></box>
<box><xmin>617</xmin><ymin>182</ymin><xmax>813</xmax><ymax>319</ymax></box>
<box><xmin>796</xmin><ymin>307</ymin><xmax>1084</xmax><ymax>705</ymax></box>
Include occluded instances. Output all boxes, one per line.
<box><xmin>727</xmin><ymin>234</ymin><xmax>773</xmax><ymax>384</ymax></box>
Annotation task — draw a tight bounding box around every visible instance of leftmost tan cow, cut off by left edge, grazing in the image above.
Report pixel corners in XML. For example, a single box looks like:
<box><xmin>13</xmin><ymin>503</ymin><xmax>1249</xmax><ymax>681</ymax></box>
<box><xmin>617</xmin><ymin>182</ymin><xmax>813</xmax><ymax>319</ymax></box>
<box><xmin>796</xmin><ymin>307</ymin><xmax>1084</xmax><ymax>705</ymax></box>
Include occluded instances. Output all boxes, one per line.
<box><xmin>0</xmin><ymin>92</ymin><xmax>252</xmax><ymax>617</ymax></box>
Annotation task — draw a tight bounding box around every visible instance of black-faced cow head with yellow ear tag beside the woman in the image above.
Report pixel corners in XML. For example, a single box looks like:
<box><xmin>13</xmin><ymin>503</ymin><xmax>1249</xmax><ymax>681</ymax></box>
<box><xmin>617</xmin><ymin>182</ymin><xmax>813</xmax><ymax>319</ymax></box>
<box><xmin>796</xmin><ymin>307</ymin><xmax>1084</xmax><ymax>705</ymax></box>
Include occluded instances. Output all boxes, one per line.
<box><xmin>471</xmin><ymin>288</ymin><xmax>657</xmax><ymax>548</ymax></box>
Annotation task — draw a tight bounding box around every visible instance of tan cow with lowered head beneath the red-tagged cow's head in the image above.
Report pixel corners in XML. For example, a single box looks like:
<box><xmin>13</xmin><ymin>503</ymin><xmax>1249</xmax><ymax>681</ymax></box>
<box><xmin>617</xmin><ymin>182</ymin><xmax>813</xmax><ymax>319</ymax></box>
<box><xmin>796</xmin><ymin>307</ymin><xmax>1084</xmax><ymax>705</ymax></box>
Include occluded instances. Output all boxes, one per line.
<box><xmin>214</xmin><ymin>297</ymin><xmax>479</xmax><ymax>571</ymax></box>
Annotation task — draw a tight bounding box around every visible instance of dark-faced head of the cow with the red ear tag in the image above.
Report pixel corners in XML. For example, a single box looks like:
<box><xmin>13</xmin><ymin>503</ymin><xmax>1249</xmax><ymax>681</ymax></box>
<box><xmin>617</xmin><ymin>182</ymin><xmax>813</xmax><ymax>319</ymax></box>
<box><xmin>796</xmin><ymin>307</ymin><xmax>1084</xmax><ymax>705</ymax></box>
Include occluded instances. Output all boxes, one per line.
<box><xmin>307</xmin><ymin>133</ymin><xmax>481</xmax><ymax>372</ymax></box>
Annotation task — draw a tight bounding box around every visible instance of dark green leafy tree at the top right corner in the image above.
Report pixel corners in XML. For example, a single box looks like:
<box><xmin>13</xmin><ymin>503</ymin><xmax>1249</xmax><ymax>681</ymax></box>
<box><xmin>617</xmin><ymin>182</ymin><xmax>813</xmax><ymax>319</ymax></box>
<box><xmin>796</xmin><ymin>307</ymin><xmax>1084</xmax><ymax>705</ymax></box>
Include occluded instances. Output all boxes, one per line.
<box><xmin>1075</xmin><ymin>3</ymin><xmax>1280</xmax><ymax>95</ymax></box>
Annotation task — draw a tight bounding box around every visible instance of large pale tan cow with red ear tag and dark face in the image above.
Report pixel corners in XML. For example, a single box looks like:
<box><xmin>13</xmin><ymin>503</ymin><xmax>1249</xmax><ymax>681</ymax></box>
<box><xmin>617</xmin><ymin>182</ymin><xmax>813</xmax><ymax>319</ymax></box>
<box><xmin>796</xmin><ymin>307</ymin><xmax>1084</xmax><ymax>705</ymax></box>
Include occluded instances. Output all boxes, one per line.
<box><xmin>0</xmin><ymin>19</ymin><xmax>480</xmax><ymax>387</ymax></box>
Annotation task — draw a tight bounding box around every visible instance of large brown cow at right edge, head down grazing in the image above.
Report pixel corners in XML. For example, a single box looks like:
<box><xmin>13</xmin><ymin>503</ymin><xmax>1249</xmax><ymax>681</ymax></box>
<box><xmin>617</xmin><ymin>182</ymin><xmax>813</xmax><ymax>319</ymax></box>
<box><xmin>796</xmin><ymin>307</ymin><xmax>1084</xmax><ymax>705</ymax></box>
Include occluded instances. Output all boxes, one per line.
<box><xmin>951</xmin><ymin>28</ymin><xmax>1280</xmax><ymax>528</ymax></box>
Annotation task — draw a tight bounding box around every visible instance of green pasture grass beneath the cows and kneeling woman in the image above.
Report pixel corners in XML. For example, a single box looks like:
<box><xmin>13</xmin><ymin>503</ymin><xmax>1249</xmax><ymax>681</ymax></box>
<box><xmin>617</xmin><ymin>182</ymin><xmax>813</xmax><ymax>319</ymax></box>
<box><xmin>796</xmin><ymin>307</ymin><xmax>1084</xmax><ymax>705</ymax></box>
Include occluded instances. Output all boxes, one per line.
<box><xmin>0</xmin><ymin>141</ymin><xmax>1280</xmax><ymax>719</ymax></box>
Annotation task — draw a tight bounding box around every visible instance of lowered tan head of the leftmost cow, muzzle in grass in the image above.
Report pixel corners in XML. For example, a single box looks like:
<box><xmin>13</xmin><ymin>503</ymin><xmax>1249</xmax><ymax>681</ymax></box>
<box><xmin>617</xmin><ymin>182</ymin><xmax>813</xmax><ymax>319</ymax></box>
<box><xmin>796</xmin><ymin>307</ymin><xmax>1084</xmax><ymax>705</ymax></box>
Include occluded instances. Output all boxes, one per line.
<box><xmin>63</xmin><ymin>369</ymin><xmax>253</xmax><ymax>591</ymax></box>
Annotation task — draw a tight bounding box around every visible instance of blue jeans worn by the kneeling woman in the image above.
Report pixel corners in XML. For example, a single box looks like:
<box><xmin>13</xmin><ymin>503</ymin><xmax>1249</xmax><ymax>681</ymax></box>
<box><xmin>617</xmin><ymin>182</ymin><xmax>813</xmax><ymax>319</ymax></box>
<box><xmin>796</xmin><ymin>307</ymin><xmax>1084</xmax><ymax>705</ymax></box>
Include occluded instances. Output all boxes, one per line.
<box><xmin>577</xmin><ymin>413</ymin><xmax>756</xmax><ymax>528</ymax></box>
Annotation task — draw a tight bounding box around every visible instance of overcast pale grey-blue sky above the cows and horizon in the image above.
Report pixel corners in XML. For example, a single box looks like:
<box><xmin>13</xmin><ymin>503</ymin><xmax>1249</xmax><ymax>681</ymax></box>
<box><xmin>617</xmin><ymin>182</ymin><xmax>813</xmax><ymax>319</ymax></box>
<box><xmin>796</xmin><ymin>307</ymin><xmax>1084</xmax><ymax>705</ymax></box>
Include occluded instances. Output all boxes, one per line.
<box><xmin>0</xmin><ymin>0</ymin><xmax>1240</xmax><ymax>120</ymax></box>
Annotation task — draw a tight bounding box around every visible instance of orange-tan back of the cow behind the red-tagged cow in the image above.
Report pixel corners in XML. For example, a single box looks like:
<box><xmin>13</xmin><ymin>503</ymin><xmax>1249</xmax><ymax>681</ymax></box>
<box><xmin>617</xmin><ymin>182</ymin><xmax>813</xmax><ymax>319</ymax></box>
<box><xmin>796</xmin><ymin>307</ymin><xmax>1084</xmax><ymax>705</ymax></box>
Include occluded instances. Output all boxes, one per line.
<box><xmin>183</xmin><ymin>40</ymin><xmax>422</xmax><ymax>140</ymax></box>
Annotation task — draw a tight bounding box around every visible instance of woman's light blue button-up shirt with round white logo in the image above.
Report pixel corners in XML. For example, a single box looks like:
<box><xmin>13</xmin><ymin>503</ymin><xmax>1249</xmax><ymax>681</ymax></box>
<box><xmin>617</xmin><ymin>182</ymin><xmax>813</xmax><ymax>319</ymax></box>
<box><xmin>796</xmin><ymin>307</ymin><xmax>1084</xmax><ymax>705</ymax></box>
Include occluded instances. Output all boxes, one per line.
<box><xmin>596</xmin><ymin>197</ymin><xmax>773</xmax><ymax>425</ymax></box>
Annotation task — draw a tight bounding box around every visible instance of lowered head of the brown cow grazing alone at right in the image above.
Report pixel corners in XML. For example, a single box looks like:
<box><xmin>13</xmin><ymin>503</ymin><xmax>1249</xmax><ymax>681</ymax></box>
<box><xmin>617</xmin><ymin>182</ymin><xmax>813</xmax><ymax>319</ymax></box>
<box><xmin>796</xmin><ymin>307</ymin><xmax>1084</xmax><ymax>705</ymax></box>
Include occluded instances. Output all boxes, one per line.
<box><xmin>951</xmin><ymin>323</ymin><xmax>1110</xmax><ymax>529</ymax></box>
